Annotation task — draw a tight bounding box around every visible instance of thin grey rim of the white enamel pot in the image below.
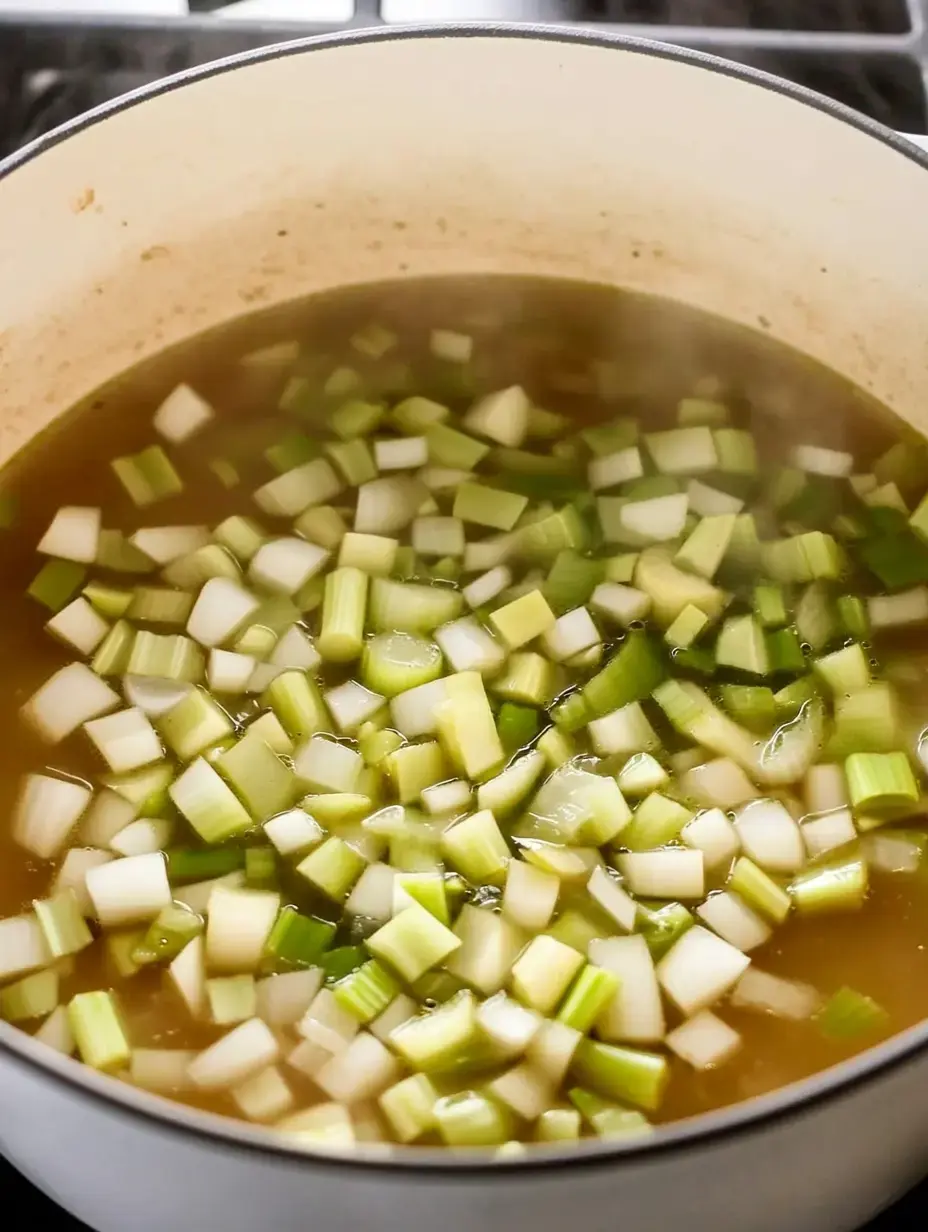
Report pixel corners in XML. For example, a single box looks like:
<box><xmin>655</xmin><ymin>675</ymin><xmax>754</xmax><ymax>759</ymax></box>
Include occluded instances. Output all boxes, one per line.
<box><xmin>0</xmin><ymin>22</ymin><xmax>928</xmax><ymax>1183</ymax></box>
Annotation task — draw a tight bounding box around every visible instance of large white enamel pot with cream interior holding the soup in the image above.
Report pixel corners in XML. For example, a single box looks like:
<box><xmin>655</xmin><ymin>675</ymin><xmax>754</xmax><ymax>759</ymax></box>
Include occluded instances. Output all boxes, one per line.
<box><xmin>0</xmin><ymin>27</ymin><xmax>928</xmax><ymax>1232</ymax></box>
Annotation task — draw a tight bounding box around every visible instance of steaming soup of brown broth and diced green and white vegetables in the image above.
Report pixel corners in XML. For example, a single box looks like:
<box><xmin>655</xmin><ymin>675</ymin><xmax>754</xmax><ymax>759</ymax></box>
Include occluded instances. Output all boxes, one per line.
<box><xmin>0</xmin><ymin>277</ymin><xmax>928</xmax><ymax>1147</ymax></box>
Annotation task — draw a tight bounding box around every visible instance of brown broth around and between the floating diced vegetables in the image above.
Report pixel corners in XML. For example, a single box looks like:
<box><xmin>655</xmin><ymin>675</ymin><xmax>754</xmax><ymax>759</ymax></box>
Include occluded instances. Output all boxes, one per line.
<box><xmin>0</xmin><ymin>276</ymin><xmax>928</xmax><ymax>1146</ymax></box>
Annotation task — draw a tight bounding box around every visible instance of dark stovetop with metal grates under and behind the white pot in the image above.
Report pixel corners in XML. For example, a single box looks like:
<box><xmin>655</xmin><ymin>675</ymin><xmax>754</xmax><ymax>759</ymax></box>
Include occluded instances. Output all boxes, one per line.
<box><xmin>0</xmin><ymin>0</ymin><xmax>928</xmax><ymax>1232</ymax></box>
